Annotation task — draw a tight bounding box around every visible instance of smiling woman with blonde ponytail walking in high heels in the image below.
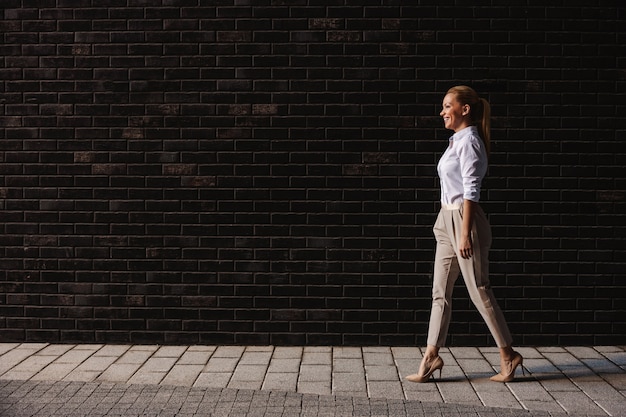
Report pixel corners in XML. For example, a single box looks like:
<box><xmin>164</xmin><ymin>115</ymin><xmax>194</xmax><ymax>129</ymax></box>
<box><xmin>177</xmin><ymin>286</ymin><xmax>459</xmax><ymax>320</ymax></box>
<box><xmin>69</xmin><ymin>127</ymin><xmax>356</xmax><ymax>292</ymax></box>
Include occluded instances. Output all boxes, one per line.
<box><xmin>406</xmin><ymin>86</ymin><xmax>523</xmax><ymax>382</ymax></box>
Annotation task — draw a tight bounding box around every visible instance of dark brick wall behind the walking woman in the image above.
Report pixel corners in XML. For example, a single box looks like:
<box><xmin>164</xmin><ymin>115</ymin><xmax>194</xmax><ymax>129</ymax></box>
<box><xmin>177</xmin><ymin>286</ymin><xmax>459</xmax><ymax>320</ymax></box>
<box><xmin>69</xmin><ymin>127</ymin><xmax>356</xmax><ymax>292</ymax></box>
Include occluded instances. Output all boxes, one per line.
<box><xmin>0</xmin><ymin>0</ymin><xmax>626</xmax><ymax>345</ymax></box>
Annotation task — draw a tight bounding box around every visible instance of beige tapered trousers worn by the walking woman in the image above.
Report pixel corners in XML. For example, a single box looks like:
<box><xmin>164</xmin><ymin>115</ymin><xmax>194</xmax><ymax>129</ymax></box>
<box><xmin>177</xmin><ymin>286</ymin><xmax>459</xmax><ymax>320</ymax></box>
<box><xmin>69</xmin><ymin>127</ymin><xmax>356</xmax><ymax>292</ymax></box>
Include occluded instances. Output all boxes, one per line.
<box><xmin>428</xmin><ymin>205</ymin><xmax>513</xmax><ymax>347</ymax></box>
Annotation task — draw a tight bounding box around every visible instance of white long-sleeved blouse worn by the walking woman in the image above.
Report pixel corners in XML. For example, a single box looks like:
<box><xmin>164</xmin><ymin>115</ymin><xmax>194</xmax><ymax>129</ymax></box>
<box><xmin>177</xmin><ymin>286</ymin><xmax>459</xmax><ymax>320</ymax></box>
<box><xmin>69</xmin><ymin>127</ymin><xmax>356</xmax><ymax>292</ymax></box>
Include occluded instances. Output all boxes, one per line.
<box><xmin>437</xmin><ymin>126</ymin><xmax>488</xmax><ymax>204</ymax></box>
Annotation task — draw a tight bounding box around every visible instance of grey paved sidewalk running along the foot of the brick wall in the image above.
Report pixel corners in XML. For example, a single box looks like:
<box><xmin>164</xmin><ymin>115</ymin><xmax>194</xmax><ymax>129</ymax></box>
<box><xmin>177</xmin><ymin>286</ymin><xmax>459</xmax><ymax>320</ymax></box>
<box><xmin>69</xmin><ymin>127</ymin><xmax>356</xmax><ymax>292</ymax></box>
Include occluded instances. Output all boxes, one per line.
<box><xmin>0</xmin><ymin>343</ymin><xmax>626</xmax><ymax>417</ymax></box>
